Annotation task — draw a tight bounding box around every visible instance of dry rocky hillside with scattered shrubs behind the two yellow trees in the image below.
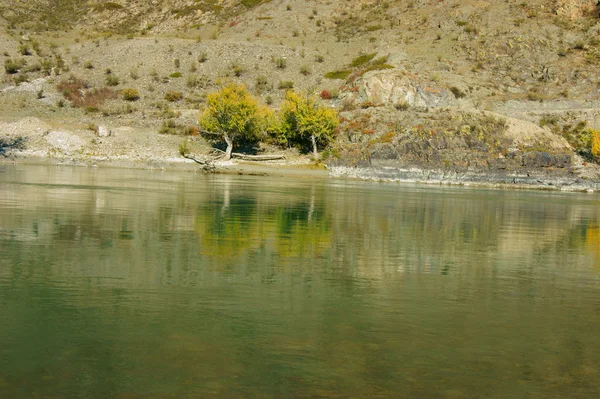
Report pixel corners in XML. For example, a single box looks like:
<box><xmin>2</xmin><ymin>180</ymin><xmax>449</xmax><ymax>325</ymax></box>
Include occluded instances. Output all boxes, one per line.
<box><xmin>0</xmin><ymin>0</ymin><xmax>600</xmax><ymax>188</ymax></box>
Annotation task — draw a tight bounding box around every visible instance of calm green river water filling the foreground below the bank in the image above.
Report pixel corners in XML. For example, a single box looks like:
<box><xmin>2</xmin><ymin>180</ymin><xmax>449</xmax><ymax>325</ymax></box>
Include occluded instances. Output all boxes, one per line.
<box><xmin>0</xmin><ymin>166</ymin><xmax>600</xmax><ymax>399</ymax></box>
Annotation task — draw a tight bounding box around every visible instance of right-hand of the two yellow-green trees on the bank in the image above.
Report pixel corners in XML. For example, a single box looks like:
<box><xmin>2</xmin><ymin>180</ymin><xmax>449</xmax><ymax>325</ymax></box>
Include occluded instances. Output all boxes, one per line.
<box><xmin>280</xmin><ymin>91</ymin><xmax>339</xmax><ymax>158</ymax></box>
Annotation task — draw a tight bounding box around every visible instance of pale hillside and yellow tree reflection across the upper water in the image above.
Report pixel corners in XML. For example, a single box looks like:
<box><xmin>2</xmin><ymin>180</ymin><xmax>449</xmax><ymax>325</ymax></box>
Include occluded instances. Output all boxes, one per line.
<box><xmin>0</xmin><ymin>168</ymin><xmax>598</xmax><ymax>284</ymax></box>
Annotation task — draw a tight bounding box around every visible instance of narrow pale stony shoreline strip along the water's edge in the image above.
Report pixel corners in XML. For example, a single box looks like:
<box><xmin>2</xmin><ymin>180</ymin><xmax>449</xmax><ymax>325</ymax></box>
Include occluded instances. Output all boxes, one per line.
<box><xmin>0</xmin><ymin>154</ymin><xmax>600</xmax><ymax>193</ymax></box>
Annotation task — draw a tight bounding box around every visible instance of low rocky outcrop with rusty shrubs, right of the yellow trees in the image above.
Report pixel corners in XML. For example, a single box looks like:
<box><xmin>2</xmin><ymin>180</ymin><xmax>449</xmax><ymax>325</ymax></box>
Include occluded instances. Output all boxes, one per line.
<box><xmin>328</xmin><ymin>107</ymin><xmax>575</xmax><ymax>179</ymax></box>
